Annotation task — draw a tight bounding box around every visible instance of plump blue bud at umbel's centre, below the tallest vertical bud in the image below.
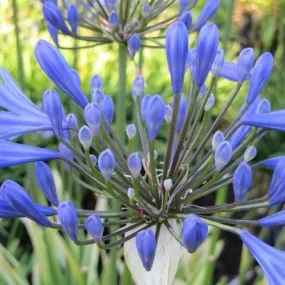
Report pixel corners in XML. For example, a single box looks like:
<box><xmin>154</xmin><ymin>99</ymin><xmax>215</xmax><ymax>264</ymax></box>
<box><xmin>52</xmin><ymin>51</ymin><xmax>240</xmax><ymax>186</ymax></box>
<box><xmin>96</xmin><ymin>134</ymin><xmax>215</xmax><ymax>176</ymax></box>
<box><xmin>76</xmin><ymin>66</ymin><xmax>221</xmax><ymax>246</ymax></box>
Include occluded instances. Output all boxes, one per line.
<box><xmin>146</xmin><ymin>95</ymin><xmax>165</xmax><ymax>141</ymax></box>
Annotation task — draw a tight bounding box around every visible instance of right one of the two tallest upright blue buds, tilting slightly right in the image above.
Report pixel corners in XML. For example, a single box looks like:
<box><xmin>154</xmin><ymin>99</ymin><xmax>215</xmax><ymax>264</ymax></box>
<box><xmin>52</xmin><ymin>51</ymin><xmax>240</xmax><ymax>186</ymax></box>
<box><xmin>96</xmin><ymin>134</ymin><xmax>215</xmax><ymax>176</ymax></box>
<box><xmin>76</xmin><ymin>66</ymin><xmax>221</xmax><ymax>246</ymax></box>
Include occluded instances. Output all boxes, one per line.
<box><xmin>194</xmin><ymin>24</ymin><xmax>219</xmax><ymax>87</ymax></box>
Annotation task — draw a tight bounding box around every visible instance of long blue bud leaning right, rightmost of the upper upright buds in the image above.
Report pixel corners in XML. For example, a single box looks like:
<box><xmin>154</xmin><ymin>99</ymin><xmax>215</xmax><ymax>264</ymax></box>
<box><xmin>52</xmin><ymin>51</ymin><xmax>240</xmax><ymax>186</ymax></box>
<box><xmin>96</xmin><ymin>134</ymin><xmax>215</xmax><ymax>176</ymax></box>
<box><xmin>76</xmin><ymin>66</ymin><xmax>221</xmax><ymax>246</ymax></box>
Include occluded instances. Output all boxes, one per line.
<box><xmin>246</xmin><ymin>52</ymin><xmax>274</xmax><ymax>104</ymax></box>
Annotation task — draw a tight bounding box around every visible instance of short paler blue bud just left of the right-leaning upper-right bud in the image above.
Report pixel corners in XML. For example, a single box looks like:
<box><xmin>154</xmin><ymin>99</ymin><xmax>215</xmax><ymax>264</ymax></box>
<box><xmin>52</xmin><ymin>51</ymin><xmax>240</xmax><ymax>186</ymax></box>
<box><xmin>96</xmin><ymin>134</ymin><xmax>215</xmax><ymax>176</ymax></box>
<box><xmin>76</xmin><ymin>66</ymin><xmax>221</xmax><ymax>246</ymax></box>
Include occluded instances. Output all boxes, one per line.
<box><xmin>237</xmin><ymin>48</ymin><xmax>254</xmax><ymax>82</ymax></box>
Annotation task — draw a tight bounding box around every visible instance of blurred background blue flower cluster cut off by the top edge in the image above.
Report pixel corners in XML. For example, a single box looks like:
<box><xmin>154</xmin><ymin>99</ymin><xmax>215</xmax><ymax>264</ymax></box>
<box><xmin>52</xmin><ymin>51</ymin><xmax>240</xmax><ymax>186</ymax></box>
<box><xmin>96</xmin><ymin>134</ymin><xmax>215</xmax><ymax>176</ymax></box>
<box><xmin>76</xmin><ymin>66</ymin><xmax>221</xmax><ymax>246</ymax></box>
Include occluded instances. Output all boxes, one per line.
<box><xmin>39</xmin><ymin>0</ymin><xmax>220</xmax><ymax>53</ymax></box>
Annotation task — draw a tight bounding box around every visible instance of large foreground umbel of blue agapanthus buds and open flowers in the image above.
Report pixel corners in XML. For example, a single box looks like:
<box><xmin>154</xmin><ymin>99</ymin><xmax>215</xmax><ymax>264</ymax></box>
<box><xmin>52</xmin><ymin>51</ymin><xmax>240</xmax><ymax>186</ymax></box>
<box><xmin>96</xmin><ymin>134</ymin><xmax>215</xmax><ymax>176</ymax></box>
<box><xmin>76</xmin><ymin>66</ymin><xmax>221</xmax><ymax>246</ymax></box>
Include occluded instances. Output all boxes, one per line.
<box><xmin>0</xmin><ymin>13</ymin><xmax>285</xmax><ymax>284</ymax></box>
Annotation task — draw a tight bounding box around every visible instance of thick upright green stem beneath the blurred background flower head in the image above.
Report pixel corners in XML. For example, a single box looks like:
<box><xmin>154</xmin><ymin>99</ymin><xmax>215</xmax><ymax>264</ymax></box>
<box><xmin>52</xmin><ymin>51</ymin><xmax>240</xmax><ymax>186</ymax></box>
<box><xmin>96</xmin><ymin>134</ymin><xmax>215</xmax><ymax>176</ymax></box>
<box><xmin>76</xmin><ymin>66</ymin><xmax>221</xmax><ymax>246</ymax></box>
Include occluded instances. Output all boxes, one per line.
<box><xmin>116</xmin><ymin>44</ymin><xmax>128</xmax><ymax>141</ymax></box>
